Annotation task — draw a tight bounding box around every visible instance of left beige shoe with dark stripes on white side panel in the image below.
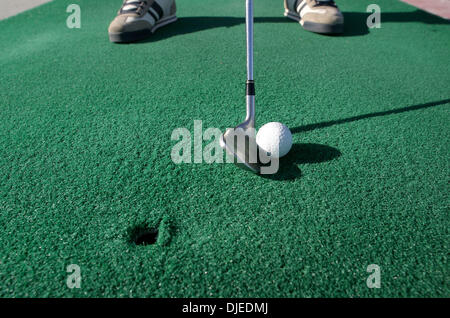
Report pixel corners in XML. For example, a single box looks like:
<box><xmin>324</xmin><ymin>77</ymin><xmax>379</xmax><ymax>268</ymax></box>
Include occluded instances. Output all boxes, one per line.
<box><xmin>108</xmin><ymin>0</ymin><xmax>177</xmax><ymax>42</ymax></box>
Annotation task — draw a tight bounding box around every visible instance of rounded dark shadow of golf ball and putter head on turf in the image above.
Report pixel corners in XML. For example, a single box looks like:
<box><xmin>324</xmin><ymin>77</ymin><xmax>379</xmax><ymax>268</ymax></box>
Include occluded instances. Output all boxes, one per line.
<box><xmin>263</xmin><ymin>144</ymin><xmax>341</xmax><ymax>181</ymax></box>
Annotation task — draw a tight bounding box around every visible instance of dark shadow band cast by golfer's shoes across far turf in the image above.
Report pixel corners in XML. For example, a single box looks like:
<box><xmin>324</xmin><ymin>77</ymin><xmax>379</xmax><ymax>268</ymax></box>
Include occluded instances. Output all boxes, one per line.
<box><xmin>136</xmin><ymin>10</ymin><xmax>448</xmax><ymax>43</ymax></box>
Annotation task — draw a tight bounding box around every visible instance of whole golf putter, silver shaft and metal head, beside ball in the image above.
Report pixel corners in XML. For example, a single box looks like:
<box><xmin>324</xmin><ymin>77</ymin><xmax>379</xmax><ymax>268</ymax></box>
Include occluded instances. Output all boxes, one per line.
<box><xmin>220</xmin><ymin>0</ymin><xmax>262</xmax><ymax>174</ymax></box>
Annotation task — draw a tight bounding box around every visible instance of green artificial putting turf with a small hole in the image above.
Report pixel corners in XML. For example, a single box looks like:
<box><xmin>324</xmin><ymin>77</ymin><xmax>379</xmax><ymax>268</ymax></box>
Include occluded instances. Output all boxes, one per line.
<box><xmin>0</xmin><ymin>0</ymin><xmax>450</xmax><ymax>297</ymax></box>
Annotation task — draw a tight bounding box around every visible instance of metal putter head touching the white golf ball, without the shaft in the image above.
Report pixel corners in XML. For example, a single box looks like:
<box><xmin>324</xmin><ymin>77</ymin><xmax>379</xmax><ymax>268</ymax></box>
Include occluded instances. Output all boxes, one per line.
<box><xmin>220</xmin><ymin>123</ymin><xmax>263</xmax><ymax>174</ymax></box>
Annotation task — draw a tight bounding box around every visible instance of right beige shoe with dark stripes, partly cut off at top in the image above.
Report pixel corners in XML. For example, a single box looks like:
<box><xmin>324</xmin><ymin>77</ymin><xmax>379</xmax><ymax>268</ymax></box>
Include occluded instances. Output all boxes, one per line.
<box><xmin>284</xmin><ymin>0</ymin><xmax>344</xmax><ymax>34</ymax></box>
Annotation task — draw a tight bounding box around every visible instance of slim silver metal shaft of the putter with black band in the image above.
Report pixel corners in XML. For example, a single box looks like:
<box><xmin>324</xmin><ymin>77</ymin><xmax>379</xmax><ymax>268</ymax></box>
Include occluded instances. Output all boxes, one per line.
<box><xmin>245</xmin><ymin>0</ymin><xmax>255</xmax><ymax>128</ymax></box>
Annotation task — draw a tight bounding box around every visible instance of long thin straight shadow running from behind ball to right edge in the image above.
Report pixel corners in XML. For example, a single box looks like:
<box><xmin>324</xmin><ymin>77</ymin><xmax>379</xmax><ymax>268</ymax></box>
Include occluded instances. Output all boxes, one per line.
<box><xmin>291</xmin><ymin>99</ymin><xmax>450</xmax><ymax>134</ymax></box>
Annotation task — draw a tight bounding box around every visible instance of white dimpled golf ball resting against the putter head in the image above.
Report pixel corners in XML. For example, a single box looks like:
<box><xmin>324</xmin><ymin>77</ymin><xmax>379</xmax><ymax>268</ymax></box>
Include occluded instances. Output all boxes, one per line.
<box><xmin>256</xmin><ymin>122</ymin><xmax>292</xmax><ymax>158</ymax></box>
